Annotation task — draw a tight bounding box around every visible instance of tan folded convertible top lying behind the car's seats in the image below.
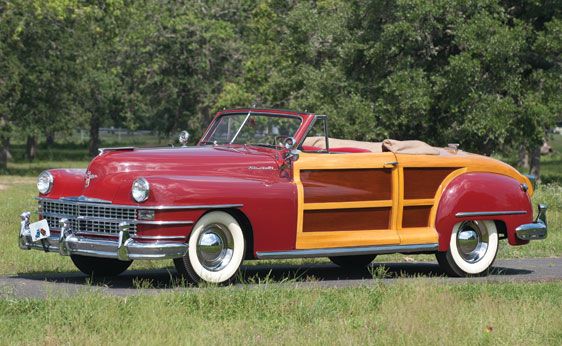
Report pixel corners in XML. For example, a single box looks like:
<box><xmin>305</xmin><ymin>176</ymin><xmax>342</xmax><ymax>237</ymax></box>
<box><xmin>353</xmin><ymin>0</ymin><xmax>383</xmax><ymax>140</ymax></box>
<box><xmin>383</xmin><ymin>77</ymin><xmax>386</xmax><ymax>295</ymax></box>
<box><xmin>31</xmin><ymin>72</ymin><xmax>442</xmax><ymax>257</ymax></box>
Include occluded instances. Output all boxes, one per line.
<box><xmin>303</xmin><ymin>137</ymin><xmax>439</xmax><ymax>155</ymax></box>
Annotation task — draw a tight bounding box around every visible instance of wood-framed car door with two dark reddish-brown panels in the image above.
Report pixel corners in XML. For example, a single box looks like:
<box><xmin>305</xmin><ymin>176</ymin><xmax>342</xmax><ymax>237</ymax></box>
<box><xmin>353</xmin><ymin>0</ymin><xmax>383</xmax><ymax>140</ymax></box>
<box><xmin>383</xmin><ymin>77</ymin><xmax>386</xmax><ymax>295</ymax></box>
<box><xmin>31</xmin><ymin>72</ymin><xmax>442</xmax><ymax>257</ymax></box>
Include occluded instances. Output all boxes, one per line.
<box><xmin>293</xmin><ymin>152</ymin><xmax>400</xmax><ymax>249</ymax></box>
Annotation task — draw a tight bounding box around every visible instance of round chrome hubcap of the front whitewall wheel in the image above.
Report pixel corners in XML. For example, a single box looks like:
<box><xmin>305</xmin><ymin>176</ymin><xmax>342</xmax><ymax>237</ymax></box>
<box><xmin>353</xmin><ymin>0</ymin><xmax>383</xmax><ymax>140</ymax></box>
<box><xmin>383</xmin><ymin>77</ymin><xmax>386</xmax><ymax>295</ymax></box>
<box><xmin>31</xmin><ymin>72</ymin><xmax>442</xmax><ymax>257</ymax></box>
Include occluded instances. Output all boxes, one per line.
<box><xmin>197</xmin><ymin>223</ymin><xmax>234</xmax><ymax>271</ymax></box>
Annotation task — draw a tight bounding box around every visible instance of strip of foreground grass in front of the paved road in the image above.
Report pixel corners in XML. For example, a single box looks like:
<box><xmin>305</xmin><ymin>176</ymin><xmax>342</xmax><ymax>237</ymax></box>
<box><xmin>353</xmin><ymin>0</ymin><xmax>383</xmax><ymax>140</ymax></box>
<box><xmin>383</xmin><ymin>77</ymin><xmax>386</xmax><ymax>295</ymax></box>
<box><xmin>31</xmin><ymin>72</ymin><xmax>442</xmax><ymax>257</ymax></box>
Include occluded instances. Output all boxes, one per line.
<box><xmin>0</xmin><ymin>279</ymin><xmax>562</xmax><ymax>345</ymax></box>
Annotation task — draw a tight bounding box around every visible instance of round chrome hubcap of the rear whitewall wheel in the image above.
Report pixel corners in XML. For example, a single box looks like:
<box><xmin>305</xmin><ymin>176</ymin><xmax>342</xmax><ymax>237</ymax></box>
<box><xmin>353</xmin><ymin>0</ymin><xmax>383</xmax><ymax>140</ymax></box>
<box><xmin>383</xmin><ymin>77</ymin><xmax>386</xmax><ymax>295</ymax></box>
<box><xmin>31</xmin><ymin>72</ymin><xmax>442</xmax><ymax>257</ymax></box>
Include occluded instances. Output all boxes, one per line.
<box><xmin>457</xmin><ymin>221</ymin><xmax>488</xmax><ymax>263</ymax></box>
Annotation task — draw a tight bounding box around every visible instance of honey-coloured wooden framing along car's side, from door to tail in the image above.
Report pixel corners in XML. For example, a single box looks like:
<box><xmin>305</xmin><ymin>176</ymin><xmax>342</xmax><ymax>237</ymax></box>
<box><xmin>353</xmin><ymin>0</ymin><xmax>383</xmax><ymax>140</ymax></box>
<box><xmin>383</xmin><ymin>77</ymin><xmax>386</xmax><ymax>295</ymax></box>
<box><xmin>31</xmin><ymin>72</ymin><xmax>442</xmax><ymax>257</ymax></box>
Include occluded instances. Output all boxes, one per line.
<box><xmin>294</xmin><ymin>150</ymin><xmax>532</xmax><ymax>249</ymax></box>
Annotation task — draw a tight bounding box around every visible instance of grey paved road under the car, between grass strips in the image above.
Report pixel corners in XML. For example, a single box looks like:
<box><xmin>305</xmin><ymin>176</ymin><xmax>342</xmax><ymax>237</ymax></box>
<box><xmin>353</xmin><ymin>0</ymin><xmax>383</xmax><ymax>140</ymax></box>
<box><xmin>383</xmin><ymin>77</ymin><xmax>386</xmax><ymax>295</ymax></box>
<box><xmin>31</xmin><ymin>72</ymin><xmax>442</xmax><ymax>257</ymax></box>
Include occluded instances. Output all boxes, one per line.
<box><xmin>0</xmin><ymin>258</ymin><xmax>562</xmax><ymax>298</ymax></box>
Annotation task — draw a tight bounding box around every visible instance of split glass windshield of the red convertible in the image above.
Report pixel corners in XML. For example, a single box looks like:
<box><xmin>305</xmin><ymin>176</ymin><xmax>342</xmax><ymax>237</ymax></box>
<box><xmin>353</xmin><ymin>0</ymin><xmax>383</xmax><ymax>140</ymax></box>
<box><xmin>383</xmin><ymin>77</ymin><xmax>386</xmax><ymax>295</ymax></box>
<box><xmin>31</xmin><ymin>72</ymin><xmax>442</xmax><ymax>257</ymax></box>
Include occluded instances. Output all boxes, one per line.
<box><xmin>201</xmin><ymin>113</ymin><xmax>301</xmax><ymax>148</ymax></box>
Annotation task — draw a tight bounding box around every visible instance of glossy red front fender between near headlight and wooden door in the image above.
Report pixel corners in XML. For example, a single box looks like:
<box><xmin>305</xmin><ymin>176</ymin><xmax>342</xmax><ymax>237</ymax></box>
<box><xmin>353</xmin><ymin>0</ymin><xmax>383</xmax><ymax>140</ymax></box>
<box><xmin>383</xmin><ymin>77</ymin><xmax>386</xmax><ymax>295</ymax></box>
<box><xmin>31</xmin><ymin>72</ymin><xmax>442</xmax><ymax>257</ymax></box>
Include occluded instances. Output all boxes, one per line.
<box><xmin>118</xmin><ymin>175</ymin><xmax>297</xmax><ymax>252</ymax></box>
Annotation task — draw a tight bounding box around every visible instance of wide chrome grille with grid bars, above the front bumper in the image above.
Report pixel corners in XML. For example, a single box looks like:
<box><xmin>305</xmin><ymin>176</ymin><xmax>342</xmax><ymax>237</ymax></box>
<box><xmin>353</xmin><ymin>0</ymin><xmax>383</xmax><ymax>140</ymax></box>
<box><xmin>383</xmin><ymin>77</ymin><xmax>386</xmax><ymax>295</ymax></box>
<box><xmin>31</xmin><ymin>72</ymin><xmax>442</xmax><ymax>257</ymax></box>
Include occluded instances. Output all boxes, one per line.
<box><xmin>39</xmin><ymin>200</ymin><xmax>136</xmax><ymax>235</ymax></box>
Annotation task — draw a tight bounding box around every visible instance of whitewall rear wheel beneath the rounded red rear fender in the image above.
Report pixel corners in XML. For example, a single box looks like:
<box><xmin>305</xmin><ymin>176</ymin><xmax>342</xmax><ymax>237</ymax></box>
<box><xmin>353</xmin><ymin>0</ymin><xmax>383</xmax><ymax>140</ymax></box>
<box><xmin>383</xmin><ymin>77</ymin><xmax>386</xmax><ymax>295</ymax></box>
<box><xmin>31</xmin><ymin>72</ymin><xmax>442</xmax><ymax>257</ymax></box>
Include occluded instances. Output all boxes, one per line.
<box><xmin>436</xmin><ymin>220</ymin><xmax>498</xmax><ymax>277</ymax></box>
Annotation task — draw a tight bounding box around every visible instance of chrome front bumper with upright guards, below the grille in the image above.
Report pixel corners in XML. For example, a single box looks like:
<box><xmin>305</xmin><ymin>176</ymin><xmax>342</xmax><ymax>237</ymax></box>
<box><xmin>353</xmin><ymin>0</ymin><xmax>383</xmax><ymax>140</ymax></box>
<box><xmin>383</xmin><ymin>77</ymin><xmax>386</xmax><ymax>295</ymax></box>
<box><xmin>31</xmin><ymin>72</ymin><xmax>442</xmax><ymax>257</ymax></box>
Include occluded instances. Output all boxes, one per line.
<box><xmin>19</xmin><ymin>212</ymin><xmax>188</xmax><ymax>261</ymax></box>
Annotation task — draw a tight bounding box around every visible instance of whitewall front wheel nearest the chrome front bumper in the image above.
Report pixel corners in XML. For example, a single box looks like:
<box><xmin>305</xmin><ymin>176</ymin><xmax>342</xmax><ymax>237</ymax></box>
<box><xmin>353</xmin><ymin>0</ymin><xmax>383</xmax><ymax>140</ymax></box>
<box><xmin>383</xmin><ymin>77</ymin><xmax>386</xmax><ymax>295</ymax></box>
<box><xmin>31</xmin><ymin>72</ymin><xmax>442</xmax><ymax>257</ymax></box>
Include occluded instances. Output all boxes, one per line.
<box><xmin>174</xmin><ymin>211</ymin><xmax>246</xmax><ymax>284</ymax></box>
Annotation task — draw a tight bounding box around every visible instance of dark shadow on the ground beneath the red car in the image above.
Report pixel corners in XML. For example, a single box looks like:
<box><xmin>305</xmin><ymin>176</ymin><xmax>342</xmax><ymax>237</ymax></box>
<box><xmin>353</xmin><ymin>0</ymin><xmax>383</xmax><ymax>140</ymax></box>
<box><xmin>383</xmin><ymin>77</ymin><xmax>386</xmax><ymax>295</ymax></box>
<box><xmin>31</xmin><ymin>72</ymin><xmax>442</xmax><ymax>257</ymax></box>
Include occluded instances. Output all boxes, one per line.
<box><xmin>10</xmin><ymin>262</ymin><xmax>533</xmax><ymax>289</ymax></box>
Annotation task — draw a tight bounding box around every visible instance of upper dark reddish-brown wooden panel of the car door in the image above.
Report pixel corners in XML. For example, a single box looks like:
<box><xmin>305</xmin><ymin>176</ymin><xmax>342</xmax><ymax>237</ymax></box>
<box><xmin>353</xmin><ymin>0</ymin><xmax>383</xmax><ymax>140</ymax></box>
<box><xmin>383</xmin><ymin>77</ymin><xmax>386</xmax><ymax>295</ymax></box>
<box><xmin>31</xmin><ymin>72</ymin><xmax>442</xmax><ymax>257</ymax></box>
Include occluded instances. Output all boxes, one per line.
<box><xmin>300</xmin><ymin>168</ymin><xmax>392</xmax><ymax>203</ymax></box>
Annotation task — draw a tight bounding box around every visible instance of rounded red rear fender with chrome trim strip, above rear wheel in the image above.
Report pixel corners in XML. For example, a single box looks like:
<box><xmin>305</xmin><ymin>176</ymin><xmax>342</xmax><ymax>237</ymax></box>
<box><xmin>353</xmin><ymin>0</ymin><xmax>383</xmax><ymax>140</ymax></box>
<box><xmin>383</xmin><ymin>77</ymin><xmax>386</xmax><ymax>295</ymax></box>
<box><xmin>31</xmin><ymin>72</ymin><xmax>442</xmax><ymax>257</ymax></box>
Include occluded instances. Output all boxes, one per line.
<box><xmin>435</xmin><ymin>172</ymin><xmax>533</xmax><ymax>251</ymax></box>
